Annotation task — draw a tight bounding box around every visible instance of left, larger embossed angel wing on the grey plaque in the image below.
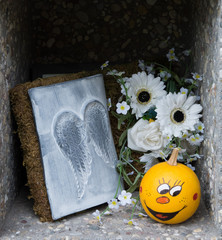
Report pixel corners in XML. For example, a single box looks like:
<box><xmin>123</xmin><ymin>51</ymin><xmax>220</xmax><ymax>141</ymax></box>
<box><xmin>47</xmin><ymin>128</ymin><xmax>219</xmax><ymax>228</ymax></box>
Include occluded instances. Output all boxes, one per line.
<box><xmin>54</xmin><ymin>111</ymin><xmax>92</xmax><ymax>198</ymax></box>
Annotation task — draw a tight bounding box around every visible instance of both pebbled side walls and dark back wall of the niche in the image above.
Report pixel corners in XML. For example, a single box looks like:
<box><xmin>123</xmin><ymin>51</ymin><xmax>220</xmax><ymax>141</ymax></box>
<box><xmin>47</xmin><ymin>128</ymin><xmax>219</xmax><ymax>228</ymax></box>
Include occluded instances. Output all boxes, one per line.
<box><xmin>0</xmin><ymin>0</ymin><xmax>222</xmax><ymax>234</ymax></box>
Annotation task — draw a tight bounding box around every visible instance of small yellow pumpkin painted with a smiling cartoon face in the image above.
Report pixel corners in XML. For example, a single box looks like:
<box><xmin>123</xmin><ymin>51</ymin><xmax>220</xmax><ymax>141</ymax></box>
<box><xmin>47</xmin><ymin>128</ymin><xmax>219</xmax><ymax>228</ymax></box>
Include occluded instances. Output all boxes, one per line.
<box><xmin>140</xmin><ymin>148</ymin><xmax>201</xmax><ymax>224</ymax></box>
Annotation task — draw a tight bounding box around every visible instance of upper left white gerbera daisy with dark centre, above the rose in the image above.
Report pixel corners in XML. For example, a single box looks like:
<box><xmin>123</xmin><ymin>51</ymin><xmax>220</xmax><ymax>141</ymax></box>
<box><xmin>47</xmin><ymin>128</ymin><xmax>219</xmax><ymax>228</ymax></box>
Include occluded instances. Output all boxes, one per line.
<box><xmin>128</xmin><ymin>71</ymin><xmax>166</xmax><ymax>119</ymax></box>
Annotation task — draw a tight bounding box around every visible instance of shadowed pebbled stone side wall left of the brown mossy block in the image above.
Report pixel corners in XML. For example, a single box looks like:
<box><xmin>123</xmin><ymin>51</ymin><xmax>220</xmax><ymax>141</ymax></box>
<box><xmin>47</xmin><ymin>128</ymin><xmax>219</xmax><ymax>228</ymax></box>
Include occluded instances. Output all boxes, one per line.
<box><xmin>0</xmin><ymin>0</ymin><xmax>29</xmax><ymax>231</ymax></box>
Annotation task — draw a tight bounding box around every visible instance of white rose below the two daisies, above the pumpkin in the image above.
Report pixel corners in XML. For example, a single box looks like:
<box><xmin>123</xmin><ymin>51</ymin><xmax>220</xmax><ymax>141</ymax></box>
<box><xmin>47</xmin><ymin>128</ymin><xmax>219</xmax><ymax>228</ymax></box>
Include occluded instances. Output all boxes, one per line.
<box><xmin>127</xmin><ymin>119</ymin><xmax>164</xmax><ymax>152</ymax></box>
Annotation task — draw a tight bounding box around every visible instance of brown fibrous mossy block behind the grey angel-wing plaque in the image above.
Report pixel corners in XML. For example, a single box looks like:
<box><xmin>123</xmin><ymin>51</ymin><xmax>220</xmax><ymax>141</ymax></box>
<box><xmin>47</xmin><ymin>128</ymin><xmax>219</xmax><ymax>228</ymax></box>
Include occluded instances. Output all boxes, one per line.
<box><xmin>10</xmin><ymin>63</ymin><xmax>139</xmax><ymax>222</ymax></box>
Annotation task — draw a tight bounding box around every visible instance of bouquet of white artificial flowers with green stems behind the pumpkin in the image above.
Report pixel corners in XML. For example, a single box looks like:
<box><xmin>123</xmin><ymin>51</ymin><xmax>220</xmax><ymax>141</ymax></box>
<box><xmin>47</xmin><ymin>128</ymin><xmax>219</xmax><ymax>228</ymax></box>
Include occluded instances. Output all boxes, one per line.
<box><xmin>91</xmin><ymin>48</ymin><xmax>204</xmax><ymax>224</ymax></box>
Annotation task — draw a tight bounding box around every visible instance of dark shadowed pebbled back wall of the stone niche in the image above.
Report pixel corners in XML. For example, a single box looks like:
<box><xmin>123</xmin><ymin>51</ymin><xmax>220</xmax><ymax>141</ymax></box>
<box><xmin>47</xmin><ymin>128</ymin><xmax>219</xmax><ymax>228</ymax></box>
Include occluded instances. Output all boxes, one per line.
<box><xmin>32</xmin><ymin>0</ymin><xmax>191</xmax><ymax>64</ymax></box>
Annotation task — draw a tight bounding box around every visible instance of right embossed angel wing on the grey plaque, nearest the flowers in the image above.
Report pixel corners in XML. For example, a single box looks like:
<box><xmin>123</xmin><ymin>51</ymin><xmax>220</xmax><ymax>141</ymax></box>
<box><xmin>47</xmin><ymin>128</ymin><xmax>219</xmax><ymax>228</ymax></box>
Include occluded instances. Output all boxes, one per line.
<box><xmin>85</xmin><ymin>101</ymin><xmax>117</xmax><ymax>168</ymax></box>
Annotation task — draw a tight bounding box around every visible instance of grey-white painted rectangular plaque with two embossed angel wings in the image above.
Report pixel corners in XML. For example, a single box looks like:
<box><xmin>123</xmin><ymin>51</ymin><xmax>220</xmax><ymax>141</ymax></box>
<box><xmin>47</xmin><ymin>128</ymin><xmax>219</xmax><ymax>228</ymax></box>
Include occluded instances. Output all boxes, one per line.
<box><xmin>29</xmin><ymin>74</ymin><xmax>118</xmax><ymax>220</ymax></box>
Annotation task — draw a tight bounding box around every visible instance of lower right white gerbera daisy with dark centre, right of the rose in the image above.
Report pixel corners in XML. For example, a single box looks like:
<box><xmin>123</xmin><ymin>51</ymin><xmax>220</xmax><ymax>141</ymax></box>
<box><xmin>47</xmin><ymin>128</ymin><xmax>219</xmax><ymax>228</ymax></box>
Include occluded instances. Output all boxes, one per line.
<box><xmin>155</xmin><ymin>93</ymin><xmax>202</xmax><ymax>137</ymax></box>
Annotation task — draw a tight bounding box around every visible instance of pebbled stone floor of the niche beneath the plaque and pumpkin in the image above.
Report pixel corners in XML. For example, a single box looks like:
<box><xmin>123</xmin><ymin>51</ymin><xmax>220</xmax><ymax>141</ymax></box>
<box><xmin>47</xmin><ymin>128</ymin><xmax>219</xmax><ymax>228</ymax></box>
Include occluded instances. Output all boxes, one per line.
<box><xmin>0</xmin><ymin>188</ymin><xmax>222</xmax><ymax>240</ymax></box>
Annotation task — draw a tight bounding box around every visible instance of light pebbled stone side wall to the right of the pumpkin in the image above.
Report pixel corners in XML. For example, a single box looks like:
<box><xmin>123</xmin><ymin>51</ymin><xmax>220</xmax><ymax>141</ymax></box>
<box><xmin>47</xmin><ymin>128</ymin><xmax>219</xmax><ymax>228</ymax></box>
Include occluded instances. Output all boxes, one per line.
<box><xmin>190</xmin><ymin>0</ymin><xmax>222</xmax><ymax>231</ymax></box>
